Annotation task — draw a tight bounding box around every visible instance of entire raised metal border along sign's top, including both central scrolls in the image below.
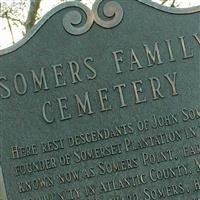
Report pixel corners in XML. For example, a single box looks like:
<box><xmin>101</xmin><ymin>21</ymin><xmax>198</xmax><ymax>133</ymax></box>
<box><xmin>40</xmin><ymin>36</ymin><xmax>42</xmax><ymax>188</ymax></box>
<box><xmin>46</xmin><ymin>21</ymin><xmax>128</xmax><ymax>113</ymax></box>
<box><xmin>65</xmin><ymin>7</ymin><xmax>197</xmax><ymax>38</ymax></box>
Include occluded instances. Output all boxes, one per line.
<box><xmin>0</xmin><ymin>0</ymin><xmax>200</xmax><ymax>56</ymax></box>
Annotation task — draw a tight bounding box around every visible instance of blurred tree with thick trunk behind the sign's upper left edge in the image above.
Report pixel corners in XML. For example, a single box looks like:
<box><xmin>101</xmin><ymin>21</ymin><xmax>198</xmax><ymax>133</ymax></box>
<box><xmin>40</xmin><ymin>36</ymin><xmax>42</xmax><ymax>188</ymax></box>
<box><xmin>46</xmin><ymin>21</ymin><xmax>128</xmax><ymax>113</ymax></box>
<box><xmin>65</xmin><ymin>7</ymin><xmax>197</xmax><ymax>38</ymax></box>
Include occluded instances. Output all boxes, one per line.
<box><xmin>0</xmin><ymin>0</ymin><xmax>80</xmax><ymax>44</ymax></box>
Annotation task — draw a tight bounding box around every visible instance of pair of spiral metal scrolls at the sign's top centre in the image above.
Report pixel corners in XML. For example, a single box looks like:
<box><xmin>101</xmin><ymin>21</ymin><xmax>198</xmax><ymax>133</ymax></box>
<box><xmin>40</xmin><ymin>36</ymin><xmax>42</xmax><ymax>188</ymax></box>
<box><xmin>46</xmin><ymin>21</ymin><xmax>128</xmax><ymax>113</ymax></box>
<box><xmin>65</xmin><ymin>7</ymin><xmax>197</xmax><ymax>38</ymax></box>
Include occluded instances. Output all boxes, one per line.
<box><xmin>63</xmin><ymin>0</ymin><xmax>124</xmax><ymax>35</ymax></box>
